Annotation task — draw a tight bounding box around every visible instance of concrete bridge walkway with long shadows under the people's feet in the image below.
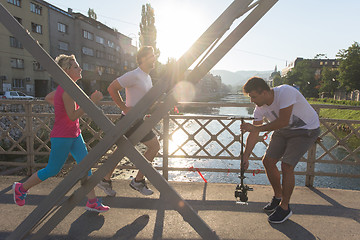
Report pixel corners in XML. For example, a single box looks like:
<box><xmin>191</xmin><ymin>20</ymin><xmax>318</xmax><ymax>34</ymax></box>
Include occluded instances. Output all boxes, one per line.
<box><xmin>0</xmin><ymin>176</ymin><xmax>360</xmax><ymax>240</ymax></box>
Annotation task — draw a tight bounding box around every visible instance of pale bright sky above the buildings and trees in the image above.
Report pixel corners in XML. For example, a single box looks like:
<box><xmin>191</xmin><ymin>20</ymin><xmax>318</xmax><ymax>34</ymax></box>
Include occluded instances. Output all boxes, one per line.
<box><xmin>43</xmin><ymin>0</ymin><xmax>360</xmax><ymax>72</ymax></box>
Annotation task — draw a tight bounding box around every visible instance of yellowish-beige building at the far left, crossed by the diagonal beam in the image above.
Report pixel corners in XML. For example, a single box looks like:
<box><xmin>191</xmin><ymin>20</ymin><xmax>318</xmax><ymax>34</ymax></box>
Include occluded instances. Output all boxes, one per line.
<box><xmin>0</xmin><ymin>0</ymin><xmax>50</xmax><ymax>97</ymax></box>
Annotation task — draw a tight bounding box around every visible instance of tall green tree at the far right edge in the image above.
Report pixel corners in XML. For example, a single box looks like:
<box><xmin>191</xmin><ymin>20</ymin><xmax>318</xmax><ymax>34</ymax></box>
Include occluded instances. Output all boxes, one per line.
<box><xmin>336</xmin><ymin>42</ymin><xmax>360</xmax><ymax>91</ymax></box>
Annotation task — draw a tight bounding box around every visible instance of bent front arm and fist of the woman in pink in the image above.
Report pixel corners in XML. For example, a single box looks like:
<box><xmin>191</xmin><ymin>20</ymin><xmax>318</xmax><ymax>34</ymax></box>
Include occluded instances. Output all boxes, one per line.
<box><xmin>62</xmin><ymin>90</ymin><xmax>103</xmax><ymax>121</ymax></box>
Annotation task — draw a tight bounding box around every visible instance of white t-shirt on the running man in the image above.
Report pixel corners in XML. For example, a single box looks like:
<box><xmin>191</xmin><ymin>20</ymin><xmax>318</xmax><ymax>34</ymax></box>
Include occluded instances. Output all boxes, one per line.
<box><xmin>116</xmin><ymin>67</ymin><xmax>152</xmax><ymax>107</ymax></box>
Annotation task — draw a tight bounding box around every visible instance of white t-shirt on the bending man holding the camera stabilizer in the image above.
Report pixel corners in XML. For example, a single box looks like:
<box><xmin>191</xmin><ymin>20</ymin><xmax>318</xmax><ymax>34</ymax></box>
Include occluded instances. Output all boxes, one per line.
<box><xmin>254</xmin><ymin>85</ymin><xmax>320</xmax><ymax>129</ymax></box>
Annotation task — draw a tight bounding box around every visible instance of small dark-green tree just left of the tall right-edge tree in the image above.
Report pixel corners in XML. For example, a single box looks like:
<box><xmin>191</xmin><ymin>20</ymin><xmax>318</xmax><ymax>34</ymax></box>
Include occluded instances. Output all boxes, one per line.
<box><xmin>319</xmin><ymin>67</ymin><xmax>339</xmax><ymax>95</ymax></box>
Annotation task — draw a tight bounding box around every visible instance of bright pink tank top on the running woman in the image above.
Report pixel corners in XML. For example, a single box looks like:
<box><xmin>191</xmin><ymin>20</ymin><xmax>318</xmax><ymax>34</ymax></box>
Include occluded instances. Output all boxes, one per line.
<box><xmin>50</xmin><ymin>86</ymin><xmax>81</xmax><ymax>138</ymax></box>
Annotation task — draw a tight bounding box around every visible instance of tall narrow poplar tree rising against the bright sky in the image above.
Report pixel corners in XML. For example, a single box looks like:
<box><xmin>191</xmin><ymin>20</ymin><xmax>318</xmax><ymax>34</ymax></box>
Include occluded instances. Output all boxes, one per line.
<box><xmin>139</xmin><ymin>3</ymin><xmax>160</xmax><ymax>55</ymax></box>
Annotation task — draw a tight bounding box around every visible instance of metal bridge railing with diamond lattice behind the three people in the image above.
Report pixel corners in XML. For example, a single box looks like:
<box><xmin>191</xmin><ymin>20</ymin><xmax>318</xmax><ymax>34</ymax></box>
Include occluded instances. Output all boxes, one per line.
<box><xmin>0</xmin><ymin>100</ymin><xmax>360</xmax><ymax>186</ymax></box>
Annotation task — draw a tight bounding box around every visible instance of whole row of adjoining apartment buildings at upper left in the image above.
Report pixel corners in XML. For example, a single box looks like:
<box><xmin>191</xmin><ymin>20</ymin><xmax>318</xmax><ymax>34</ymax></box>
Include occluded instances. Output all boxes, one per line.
<box><xmin>0</xmin><ymin>0</ymin><xmax>137</xmax><ymax>97</ymax></box>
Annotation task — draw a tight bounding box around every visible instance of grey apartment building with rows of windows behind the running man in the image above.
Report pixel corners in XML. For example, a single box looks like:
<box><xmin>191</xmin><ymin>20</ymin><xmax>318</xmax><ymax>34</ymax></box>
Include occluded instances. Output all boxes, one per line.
<box><xmin>73</xmin><ymin>13</ymin><xmax>136</xmax><ymax>94</ymax></box>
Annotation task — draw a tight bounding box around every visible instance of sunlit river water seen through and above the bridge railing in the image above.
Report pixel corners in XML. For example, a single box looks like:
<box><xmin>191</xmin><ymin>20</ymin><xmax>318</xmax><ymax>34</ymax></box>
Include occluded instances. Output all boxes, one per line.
<box><xmin>155</xmin><ymin>95</ymin><xmax>360</xmax><ymax>190</ymax></box>
